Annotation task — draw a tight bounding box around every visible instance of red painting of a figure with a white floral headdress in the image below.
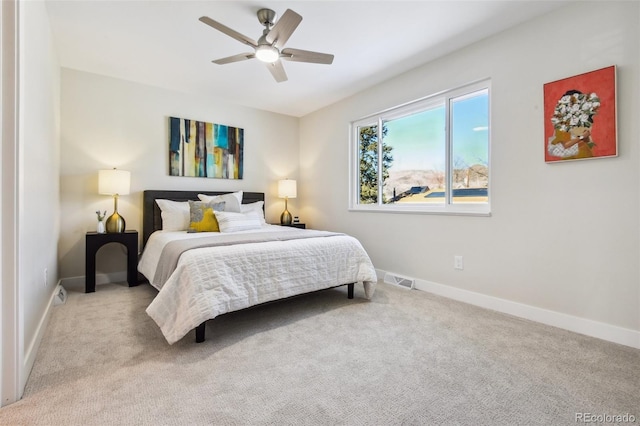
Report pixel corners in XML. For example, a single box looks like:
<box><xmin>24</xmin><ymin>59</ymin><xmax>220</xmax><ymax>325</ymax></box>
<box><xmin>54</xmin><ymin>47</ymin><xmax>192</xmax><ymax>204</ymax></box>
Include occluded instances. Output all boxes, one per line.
<box><xmin>544</xmin><ymin>65</ymin><xmax>618</xmax><ymax>163</ymax></box>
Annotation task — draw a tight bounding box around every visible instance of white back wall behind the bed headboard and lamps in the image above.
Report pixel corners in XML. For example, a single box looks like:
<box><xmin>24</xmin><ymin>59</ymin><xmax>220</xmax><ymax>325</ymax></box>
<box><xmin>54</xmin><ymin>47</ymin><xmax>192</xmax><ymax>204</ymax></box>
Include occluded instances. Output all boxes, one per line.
<box><xmin>59</xmin><ymin>68</ymin><xmax>299</xmax><ymax>286</ymax></box>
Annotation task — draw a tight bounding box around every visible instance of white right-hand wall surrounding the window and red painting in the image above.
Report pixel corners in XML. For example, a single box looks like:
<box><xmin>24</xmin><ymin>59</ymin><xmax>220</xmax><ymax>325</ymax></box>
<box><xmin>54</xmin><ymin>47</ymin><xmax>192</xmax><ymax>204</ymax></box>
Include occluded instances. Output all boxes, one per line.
<box><xmin>298</xmin><ymin>2</ymin><xmax>640</xmax><ymax>347</ymax></box>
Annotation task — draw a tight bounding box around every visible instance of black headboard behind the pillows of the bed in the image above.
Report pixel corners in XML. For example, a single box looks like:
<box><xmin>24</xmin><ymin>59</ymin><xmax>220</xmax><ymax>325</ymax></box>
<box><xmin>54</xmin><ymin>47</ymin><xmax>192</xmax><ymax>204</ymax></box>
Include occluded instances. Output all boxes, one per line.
<box><xmin>142</xmin><ymin>190</ymin><xmax>264</xmax><ymax>247</ymax></box>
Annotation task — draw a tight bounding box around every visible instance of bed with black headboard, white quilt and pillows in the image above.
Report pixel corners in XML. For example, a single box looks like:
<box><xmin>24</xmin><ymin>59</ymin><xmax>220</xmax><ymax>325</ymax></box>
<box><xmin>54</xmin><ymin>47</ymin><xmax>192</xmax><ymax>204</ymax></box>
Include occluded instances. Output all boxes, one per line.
<box><xmin>138</xmin><ymin>190</ymin><xmax>377</xmax><ymax>344</ymax></box>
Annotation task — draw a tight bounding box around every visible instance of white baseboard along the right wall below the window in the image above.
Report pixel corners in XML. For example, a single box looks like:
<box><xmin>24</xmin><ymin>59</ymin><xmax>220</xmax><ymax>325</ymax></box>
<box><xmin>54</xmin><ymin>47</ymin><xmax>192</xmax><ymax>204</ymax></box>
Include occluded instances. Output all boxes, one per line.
<box><xmin>376</xmin><ymin>270</ymin><xmax>640</xmax><ymax>349</ymax></box>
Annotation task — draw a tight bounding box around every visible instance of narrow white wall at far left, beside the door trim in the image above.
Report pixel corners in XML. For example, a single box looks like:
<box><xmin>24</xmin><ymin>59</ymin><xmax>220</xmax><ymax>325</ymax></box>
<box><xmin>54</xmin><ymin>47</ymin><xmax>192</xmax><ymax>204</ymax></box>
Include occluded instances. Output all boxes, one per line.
<box><xmin>10</xmin><ymin>2</ymin><xmax>60</xmax><ymax>402</ymax></box>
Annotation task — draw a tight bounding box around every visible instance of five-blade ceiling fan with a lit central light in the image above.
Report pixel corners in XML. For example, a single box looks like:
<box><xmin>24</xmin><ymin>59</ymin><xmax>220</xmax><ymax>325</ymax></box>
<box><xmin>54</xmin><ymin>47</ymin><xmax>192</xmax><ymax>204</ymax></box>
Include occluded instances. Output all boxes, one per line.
<box><xmin>200</xmin><ymin>9</ymin><xmax>333</xmax><ymax>83</ymax></box>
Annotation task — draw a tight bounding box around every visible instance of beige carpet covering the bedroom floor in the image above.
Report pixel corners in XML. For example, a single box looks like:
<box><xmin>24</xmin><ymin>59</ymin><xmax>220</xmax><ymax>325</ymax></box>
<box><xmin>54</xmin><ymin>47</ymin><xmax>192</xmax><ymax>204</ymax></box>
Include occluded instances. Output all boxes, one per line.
<box><xmin>0</xmin><ymin>283</ymin><xmax>640</xmax><ymax>425</ymax></box>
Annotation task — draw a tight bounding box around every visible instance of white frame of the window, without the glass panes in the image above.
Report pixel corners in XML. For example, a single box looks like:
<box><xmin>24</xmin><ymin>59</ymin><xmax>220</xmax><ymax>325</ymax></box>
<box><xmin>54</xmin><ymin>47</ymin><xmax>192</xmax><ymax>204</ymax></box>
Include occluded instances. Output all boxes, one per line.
<box><xmin>349</xmin><ymin>79</ymin><xmax>493</xmax><ymax>216</ymax></box>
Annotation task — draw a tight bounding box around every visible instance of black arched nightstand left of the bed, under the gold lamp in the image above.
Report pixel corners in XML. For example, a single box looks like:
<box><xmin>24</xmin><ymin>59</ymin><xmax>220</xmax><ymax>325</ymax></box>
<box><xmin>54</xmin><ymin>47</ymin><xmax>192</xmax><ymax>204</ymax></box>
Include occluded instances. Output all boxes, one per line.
<box><xmin>84</xmin><ymin>231</ymin><xmax>138</xmax><ymax>293</ymax></box>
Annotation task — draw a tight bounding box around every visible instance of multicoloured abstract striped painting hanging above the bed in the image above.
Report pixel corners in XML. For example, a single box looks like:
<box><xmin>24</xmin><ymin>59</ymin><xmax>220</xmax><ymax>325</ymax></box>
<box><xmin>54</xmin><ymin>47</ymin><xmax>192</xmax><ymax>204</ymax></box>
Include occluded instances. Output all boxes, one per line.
<box><xmin>169</xmin><ymin>117</ymin><xmax>244</xmax><ymax>179</ymax></box>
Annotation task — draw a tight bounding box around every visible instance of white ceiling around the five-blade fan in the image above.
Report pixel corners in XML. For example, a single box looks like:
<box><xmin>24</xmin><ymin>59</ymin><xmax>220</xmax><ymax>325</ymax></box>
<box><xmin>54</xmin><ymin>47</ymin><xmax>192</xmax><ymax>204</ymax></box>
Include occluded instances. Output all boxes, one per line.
<box><xmin>47</xmin><ymin>0</ymin><xmax>571</xmax><ymax>117</ymax></box>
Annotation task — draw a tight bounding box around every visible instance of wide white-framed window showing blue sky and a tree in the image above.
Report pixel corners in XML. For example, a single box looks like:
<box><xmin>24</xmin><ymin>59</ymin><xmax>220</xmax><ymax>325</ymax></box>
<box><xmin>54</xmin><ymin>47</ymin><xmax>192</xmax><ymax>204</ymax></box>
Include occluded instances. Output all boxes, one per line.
<box><xmin>350</xmin><ymin>81</ymin><xmax>490</xmax><ymax>214</ymax></box>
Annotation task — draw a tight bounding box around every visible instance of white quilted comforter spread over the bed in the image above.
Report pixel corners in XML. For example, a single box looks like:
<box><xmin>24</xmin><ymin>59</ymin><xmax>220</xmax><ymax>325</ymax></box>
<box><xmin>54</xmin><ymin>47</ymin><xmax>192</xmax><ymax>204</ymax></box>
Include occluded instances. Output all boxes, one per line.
<box><xmin>138</xmin><ymin>225</ymin><xmax>377</xmax><ymax>344</ymax></box>
